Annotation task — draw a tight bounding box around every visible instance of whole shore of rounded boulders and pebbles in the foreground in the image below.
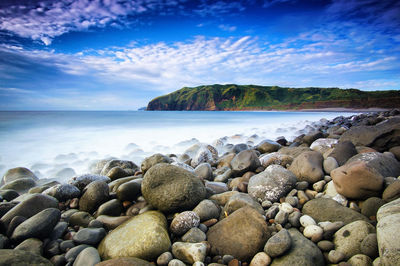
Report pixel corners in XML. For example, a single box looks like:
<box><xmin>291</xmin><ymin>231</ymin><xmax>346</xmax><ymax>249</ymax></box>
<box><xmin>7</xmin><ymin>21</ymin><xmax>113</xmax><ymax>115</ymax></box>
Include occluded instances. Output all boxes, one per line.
<box><xmin>0</xmin><ymin>110</ymin><xmax>400</xmax><ymax>266</ymax></box>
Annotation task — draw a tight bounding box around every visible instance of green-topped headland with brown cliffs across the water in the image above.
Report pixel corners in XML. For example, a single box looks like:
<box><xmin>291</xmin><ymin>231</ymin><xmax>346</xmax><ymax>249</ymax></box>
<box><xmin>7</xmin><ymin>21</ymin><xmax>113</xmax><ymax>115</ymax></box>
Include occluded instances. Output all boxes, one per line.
<box><xmin>147</xmin><ymin>84</ymin><xmax>400</xmax><ymax>111</ymax></box>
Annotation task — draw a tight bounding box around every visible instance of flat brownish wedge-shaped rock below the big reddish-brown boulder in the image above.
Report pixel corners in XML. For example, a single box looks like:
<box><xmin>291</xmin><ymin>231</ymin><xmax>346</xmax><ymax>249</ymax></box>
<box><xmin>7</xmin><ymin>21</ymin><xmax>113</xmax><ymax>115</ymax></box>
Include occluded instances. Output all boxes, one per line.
<box><xmin>302</xmin><ymin>198</ymin><xmax>368</xmax><ymax>224</ymax></box>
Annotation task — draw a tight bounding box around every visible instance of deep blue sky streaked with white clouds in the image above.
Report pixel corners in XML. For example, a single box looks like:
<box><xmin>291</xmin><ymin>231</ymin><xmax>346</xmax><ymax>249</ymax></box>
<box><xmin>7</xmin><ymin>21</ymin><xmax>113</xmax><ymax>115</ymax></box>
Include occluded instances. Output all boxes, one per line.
<box><xmin>0</xmin><ymin>0</ymin><xmax>400</xmax><ymax>110</ymax></box>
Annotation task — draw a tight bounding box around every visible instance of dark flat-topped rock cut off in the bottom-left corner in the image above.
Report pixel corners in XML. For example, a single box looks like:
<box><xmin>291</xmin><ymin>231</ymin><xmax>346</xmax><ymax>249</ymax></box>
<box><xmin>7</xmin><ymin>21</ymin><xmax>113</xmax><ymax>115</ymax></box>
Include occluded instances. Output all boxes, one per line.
<box><xmin>0</xmin><ymin>249</ymin><xmax>53</xmax><ymax>266</ymax></box>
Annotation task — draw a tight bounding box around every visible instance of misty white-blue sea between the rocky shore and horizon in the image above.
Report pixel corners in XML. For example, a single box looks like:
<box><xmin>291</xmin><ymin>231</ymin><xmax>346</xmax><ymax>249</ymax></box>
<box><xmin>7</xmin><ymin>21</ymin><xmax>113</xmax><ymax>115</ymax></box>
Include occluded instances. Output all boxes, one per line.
<box><xmin>0</xmin><ymin>111</ymin><xmax>354</xmax><ymax>181</ymax></box>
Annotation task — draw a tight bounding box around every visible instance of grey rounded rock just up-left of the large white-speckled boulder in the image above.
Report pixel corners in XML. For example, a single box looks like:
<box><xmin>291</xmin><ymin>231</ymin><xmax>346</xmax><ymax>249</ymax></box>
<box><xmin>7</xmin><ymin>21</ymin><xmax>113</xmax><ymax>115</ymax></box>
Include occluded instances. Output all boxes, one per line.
<box><xmin>231</xmin><ymin>150</ymin><xmax>261</xmax><ymax>176</ymax></box>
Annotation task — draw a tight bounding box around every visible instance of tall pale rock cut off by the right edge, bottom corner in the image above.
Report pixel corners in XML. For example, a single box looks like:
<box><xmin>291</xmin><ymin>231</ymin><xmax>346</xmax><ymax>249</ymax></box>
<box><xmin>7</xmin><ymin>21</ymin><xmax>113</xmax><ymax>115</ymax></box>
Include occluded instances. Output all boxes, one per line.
<box><xmin>376</xmin><ymin>199</ymin><xmax>400</xmax><ymax>265</ymax></box>
